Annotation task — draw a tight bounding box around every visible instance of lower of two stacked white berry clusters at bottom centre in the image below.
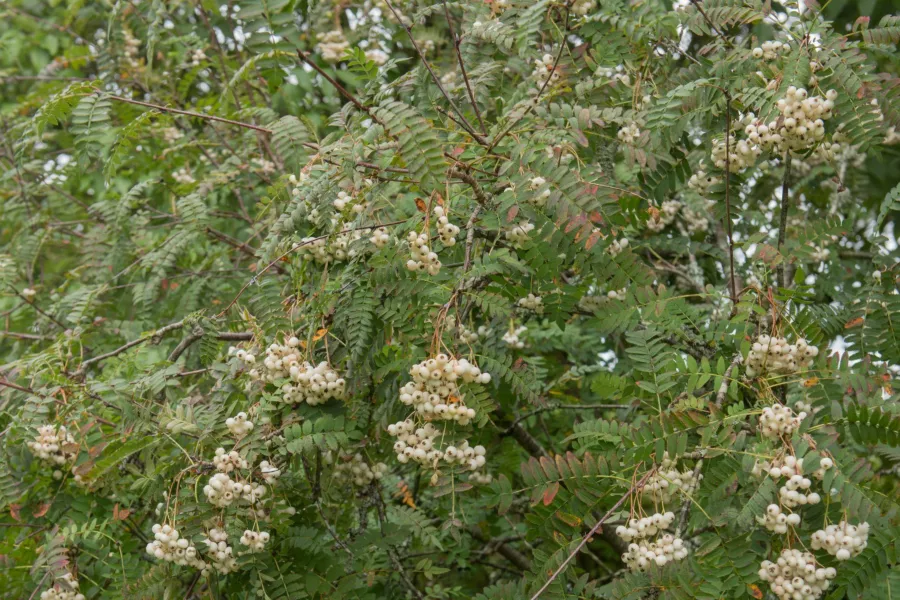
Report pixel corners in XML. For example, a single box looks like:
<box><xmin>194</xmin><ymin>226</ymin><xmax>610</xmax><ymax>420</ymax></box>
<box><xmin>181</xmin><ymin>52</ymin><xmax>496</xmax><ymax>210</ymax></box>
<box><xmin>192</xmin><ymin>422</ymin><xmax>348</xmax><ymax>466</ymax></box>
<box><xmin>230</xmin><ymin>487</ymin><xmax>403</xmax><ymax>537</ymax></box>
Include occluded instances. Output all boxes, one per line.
<box><xmin>388</xmin><ymin>419</ymin><xmax>486</xmax><ymax>471</ymax></box>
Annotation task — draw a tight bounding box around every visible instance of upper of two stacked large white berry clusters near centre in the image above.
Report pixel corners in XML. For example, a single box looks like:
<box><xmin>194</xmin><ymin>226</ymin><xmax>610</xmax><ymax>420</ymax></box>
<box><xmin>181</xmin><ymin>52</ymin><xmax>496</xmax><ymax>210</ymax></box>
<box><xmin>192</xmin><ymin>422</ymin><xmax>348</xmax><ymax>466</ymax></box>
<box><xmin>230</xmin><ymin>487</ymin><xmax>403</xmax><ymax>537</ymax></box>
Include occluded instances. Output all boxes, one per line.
<box><xmin>391</xmin><ymin>354</ymin><xmax>491</xmax><ymax>424</ymax></box>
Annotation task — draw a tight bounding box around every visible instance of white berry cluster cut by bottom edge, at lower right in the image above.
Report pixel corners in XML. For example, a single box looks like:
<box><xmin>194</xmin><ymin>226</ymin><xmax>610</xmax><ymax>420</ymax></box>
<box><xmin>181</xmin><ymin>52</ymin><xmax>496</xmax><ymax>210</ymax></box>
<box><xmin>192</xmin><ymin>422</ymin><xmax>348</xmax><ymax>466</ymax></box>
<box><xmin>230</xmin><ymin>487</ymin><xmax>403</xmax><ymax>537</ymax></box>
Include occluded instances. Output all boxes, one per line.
<box><xmin>759</xmin><ymin>548</ymin><xmax>837</xmax><ymax>600</ymax></box>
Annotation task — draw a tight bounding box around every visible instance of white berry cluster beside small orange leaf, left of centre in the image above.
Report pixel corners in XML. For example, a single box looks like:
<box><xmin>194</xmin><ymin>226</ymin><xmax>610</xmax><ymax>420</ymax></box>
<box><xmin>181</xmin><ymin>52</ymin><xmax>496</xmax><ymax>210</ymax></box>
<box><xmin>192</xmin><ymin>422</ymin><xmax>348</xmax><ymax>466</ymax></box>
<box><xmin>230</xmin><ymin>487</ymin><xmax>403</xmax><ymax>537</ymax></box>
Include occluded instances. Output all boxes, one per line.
<box><xmin>250</xmin><ymin>337</ymin><xmax>347</xmax><ymax>406</ymax></box>
